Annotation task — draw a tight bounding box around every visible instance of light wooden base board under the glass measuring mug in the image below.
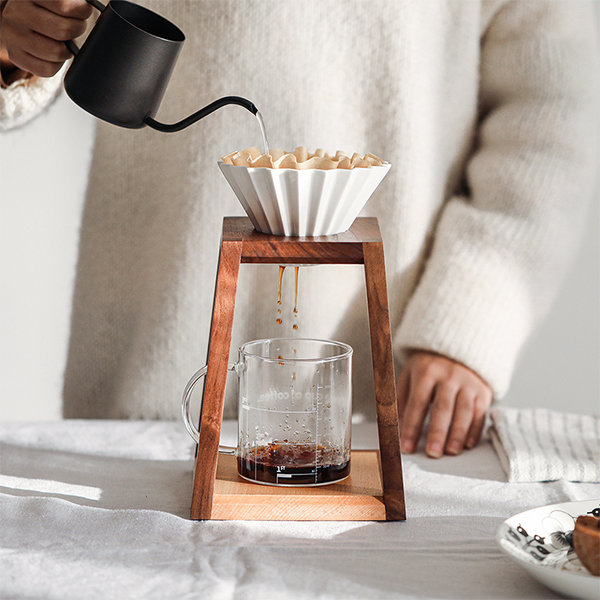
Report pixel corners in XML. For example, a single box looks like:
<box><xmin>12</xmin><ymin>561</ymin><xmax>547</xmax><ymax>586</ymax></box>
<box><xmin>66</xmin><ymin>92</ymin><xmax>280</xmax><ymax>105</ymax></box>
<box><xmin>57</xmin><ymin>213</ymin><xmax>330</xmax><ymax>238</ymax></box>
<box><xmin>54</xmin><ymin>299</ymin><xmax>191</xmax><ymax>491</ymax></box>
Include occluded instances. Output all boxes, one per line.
<box><xmin>206</xmin><ymin>450</ymin><xmax>386</xmax><ymax>521</ymax></box>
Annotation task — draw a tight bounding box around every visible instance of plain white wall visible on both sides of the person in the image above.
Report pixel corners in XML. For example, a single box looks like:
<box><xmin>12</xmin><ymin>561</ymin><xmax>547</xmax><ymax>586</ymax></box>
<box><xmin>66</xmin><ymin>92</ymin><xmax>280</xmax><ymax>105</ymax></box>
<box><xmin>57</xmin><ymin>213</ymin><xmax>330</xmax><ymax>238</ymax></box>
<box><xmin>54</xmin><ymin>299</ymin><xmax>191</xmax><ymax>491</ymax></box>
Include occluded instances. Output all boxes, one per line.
<box><xmin>0</xmin><ymin>9</ymin><xmax>600</xmax><ymax>420</ymax></box>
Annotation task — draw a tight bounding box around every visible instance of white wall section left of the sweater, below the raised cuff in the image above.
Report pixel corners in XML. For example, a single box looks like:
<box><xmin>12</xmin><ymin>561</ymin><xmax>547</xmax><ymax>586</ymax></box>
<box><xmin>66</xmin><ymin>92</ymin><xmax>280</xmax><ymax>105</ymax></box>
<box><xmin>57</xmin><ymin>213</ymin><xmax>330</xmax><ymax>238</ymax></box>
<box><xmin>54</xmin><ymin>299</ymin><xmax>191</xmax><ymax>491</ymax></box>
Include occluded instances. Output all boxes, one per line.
<box><xmin>0</xmin><ymin>94</ymin><xmax>94</xmax><ymax>420</ymax></box>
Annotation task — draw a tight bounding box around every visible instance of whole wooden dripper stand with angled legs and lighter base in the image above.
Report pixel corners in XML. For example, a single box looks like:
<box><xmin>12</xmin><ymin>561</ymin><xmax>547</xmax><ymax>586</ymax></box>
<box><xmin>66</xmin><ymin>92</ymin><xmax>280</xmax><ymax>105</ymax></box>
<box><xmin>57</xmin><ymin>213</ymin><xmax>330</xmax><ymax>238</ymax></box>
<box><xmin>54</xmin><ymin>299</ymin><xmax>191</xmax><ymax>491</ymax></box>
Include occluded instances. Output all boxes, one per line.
<box><xmin>191</xmin><ymin>217</ymin><xmax>406</xmax><ymax>521</ymax></box>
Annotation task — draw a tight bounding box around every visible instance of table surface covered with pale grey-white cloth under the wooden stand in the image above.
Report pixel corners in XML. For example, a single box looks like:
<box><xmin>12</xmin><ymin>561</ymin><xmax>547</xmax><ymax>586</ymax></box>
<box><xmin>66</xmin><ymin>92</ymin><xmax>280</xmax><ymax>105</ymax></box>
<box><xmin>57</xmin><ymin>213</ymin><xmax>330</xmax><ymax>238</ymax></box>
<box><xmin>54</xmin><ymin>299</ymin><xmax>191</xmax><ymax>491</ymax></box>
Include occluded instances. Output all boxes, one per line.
<box><xmin>0</xmin><ymin>420</ymin><xmax>600</xmax><ymax>600</ymax></box>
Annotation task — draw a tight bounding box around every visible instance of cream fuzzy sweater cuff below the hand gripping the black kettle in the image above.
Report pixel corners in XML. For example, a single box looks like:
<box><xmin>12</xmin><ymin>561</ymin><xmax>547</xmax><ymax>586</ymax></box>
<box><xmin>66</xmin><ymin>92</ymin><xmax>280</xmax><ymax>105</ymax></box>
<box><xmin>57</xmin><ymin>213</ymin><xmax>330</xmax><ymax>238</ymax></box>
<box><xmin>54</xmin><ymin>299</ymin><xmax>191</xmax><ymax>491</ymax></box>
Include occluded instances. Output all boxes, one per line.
<box><xmin>0</xmin><ymin>62</ymin><xmax>70</xmax><ymax>131</ymax></box>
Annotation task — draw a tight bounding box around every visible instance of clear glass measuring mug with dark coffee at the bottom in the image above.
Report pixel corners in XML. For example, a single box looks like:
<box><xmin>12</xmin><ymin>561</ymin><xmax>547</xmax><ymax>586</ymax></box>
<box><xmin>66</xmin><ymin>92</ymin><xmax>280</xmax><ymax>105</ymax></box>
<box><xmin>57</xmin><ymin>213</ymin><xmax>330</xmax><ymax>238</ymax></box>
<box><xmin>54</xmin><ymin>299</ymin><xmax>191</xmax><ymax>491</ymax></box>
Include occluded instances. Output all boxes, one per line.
<box><xmin>182</xmin><ymin>338</ymin><xmax>352</xmax><ymax>486</ymax></box>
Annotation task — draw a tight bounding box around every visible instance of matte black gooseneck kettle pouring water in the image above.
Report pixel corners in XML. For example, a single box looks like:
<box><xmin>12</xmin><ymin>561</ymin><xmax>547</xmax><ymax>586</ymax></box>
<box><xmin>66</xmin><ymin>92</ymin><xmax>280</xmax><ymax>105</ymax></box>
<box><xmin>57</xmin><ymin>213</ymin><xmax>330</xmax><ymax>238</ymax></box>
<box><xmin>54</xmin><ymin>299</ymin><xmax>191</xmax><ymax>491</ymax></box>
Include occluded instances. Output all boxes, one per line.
<box><xmin>64</xmin><ymin>0</ymin><xmax>258</xmax><ymax>133</ymax></box>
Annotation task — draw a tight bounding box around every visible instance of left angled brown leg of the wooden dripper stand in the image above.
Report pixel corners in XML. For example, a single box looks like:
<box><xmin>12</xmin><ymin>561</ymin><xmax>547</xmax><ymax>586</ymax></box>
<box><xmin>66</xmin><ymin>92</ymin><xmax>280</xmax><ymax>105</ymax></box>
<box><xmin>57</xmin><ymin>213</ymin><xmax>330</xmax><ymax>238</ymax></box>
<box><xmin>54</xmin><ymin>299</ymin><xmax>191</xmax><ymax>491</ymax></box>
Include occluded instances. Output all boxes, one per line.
<box><xmin>190</xmin><ymin>240</ymin><xmax>242</xmax><ymax>519</ymax></box>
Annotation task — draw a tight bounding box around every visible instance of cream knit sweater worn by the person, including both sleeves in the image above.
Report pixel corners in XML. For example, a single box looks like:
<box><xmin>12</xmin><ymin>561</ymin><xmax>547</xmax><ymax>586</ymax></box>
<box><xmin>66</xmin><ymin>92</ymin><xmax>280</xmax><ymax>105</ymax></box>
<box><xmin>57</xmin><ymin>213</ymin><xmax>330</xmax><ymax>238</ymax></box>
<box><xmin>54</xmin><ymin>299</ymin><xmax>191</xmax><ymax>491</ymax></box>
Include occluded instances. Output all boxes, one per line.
<box><xmin>0</xmin><ymin>0</ymin><xmax>598</xmax><ymax>418</ymax></box>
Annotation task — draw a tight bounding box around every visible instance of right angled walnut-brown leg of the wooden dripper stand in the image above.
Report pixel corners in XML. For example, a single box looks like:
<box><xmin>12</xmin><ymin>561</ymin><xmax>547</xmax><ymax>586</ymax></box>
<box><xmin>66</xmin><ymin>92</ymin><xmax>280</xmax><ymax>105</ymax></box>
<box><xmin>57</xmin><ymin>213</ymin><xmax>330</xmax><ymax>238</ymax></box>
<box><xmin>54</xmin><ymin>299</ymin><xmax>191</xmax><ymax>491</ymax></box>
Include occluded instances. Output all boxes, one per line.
<box><xmin>363</xmin><ymin>242</ymin><xmax>406</xmax><ymax>521</ymax></box>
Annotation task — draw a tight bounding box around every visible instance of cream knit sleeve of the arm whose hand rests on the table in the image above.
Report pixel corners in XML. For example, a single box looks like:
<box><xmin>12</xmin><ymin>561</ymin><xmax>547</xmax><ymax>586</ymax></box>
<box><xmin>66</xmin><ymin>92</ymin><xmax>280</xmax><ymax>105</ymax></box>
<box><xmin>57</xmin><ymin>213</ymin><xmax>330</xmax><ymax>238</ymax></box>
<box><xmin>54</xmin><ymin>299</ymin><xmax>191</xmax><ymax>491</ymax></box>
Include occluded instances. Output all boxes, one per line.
<box><xmin>395</xmin><ymin>1</ymin><xmax>600</xmax><ymax>397</ymax></box>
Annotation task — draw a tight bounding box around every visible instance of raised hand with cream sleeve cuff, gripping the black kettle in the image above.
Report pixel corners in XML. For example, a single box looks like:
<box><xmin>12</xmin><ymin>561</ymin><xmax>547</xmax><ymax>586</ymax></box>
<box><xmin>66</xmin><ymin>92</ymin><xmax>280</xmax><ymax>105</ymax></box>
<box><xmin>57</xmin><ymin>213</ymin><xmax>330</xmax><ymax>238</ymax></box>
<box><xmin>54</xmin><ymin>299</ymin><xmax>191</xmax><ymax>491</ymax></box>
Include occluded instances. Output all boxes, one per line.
<box><xmin>0</xmin><ymin>0</ymin><xmax>92</xmax><ymax>131</ymax></box>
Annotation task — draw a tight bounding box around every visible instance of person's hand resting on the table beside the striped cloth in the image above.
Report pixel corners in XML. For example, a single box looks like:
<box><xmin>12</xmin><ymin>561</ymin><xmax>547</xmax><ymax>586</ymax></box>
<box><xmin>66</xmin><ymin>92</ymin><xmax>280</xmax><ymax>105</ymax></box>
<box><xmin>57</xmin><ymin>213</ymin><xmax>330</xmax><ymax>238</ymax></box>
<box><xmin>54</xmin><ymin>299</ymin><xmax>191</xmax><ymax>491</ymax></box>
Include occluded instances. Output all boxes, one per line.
<box><xmin>397</xmin><ymin>351</ymin><xmax>492</xmax><ymax>458</ymax></box>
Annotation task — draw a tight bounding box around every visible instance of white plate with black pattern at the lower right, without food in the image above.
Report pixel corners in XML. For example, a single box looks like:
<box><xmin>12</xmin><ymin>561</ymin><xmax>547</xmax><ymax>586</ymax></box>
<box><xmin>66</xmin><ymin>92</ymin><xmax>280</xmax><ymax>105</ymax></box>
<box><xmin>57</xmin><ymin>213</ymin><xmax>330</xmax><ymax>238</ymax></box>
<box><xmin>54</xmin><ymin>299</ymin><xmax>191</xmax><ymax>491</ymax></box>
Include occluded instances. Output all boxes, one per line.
<box><xmin>496</xmin><ymin>499</ymin><xmax>600</xmax><ymax>600</ymax></box>
